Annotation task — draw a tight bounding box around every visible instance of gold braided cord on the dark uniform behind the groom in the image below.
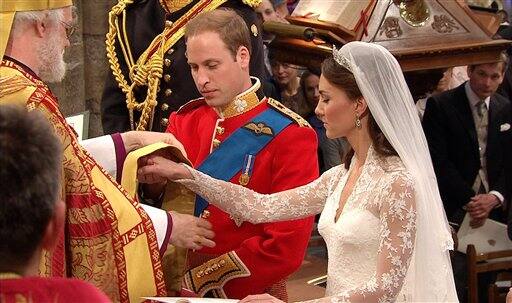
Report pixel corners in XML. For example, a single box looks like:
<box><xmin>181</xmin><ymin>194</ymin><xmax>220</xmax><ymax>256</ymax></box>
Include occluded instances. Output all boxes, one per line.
<box><xmin>106</xmin><ymin>0</ymin><xmax>227</xmax><ymax>130</ymax></box>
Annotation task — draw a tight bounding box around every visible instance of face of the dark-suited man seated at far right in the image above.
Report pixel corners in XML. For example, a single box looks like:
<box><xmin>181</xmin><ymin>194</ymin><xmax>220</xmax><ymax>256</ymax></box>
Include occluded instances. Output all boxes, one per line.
<box><xmin>468</xmin><ymin>62</ymin><xmax>504</xmax><ymax>100</ymax></box>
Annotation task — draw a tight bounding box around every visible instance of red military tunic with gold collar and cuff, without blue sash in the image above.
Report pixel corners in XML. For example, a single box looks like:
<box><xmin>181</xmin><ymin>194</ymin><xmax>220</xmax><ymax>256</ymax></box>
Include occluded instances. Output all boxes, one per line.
<box><xmin>167</xmin><ymin>80</ymin><xmax>318</xmax><ymax>300</ymax></box>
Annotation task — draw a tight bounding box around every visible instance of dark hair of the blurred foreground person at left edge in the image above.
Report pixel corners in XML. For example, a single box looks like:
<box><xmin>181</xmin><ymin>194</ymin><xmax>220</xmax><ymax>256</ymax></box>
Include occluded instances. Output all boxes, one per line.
<box><xmin>0</xmin><ymin>105</ymin><xmax>62</xmax><ymax>272</ymax></box>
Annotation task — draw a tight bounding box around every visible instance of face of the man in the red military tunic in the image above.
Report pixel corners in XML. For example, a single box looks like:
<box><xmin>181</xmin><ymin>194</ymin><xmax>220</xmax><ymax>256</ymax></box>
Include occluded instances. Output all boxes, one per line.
<box><xmin>187</xmin><ymin>32</ymin><xmax>251</xmax><ymax>108</ymax></box>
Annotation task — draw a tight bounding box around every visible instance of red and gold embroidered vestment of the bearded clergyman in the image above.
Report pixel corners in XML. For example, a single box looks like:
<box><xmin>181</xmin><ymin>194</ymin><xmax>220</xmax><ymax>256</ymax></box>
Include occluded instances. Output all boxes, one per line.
<box><xmin>0</xmin><ymin>58</ymin><xmax>166</xmax><ymax>302</ymax></box>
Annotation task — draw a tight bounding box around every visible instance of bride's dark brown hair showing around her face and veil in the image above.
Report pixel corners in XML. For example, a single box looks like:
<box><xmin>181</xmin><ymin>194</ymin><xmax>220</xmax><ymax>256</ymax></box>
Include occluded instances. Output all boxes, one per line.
<box><xmin>322</xmin><ymin>57</ymin><xmax>398</xmax><ymax>168</ymax></box>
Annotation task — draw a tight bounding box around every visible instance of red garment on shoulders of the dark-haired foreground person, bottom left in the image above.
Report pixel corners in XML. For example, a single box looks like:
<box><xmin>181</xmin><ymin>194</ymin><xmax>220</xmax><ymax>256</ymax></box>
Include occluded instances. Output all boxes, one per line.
<box><xmin>0</xmin><ymin>273</ymin><xmax>111</xmax><ymax>303</ymax></box>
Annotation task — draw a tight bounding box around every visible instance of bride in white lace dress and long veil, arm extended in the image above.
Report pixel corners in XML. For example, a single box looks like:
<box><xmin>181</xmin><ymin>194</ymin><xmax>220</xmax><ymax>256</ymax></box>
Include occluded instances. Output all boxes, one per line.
<box><xmin>139</xmin><ymin>42</ymin><xmax>457</xmax><ymax>302</ymax></box>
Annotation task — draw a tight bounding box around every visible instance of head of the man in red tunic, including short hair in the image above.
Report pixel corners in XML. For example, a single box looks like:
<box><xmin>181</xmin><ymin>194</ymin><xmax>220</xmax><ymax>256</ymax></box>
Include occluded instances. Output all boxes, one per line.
<box><xmin>185</xmin><ymin>9</ymin><xmax>251</xmax><ymax>107</ymax></box>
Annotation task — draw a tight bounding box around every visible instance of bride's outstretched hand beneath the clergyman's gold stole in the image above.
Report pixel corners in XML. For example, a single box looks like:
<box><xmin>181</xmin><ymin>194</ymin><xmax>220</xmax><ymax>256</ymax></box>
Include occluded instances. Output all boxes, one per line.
<box><xmin>137</xmin><ymin>154</ymin><xmax>193</xmax><ymax>184</ymax></box>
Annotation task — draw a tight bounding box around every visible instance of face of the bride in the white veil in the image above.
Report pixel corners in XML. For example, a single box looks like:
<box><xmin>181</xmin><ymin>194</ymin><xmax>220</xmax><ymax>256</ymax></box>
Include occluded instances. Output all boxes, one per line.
<box><xmin>315</xmin><ymin>76</ymin><xmax>357</xmax><ymax>139</ymax></box>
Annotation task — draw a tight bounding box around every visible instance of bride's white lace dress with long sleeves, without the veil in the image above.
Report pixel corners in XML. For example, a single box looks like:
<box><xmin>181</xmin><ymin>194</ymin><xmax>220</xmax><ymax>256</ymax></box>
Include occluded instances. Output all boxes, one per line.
<box><xmin>178</xmin><ymin>148</ymin><xmax>416</xmax><ymax>302</ymax></box>
